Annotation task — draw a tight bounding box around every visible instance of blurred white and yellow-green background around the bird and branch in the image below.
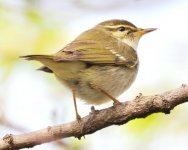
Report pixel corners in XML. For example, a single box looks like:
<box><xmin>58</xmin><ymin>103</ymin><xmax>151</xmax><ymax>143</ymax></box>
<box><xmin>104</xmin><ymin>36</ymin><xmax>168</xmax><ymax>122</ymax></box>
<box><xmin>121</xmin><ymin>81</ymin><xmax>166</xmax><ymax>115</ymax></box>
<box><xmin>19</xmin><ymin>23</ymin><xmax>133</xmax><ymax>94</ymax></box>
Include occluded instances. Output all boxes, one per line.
<box><xmin>0</xmin><ymin>0</ymin><xmax>188</xmax><ymax>150</ymax></box>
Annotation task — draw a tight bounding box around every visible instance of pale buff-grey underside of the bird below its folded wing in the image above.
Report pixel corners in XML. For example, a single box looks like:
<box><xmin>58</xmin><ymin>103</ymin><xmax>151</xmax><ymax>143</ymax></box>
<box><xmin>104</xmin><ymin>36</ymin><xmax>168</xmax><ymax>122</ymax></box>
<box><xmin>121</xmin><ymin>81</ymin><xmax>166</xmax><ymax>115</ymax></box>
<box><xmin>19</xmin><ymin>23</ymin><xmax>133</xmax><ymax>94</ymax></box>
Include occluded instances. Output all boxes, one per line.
<box><xmin>53</xmin><ymin>63</ymin><xmax>138</xmax><ymax>105</ymax></box>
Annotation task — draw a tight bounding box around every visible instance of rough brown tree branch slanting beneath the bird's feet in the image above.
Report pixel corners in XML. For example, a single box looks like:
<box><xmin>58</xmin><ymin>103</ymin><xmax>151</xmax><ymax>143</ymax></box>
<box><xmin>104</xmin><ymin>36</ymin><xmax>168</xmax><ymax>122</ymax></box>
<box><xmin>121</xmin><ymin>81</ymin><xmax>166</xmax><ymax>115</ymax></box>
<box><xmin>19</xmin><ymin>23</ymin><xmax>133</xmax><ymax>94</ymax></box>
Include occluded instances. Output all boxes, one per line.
<box><xmin>0</xmin><ymin>85</ymin><xmax>188</xmax><ymax>150</ymax></box>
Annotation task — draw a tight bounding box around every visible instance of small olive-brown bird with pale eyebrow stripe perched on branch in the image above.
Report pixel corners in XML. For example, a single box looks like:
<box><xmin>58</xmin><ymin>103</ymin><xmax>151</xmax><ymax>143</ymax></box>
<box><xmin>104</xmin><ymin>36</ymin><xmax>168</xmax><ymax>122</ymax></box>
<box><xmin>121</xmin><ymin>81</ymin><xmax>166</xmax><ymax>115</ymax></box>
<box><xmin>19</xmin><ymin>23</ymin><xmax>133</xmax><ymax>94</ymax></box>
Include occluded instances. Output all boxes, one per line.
<box><xmin>21</xmin><ymin>20</ymin><xmax>155</xmax><ymax>120</ymax></box>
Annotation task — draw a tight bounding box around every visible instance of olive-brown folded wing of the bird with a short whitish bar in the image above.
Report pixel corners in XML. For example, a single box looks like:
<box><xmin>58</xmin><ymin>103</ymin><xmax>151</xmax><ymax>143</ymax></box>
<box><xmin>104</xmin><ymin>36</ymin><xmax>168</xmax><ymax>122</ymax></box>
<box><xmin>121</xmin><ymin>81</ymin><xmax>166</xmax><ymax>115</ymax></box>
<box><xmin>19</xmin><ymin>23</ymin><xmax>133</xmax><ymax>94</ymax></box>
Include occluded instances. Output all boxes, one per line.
<box><xmin>54</xmin><ymin>35</ymin><xmax>137</xmax><ymax>68</ymax></box>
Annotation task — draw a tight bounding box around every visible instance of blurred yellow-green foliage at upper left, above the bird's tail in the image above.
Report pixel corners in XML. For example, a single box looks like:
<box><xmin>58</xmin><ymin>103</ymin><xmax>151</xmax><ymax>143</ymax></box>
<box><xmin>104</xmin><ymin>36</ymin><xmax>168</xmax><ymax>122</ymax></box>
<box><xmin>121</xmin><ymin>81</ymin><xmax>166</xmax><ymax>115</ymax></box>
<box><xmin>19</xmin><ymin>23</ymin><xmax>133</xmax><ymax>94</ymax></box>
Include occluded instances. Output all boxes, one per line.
<box><xmin>0</xmin><ymin>5</ymin><xmax>66</xmax><ymax>78</ymax></box>
